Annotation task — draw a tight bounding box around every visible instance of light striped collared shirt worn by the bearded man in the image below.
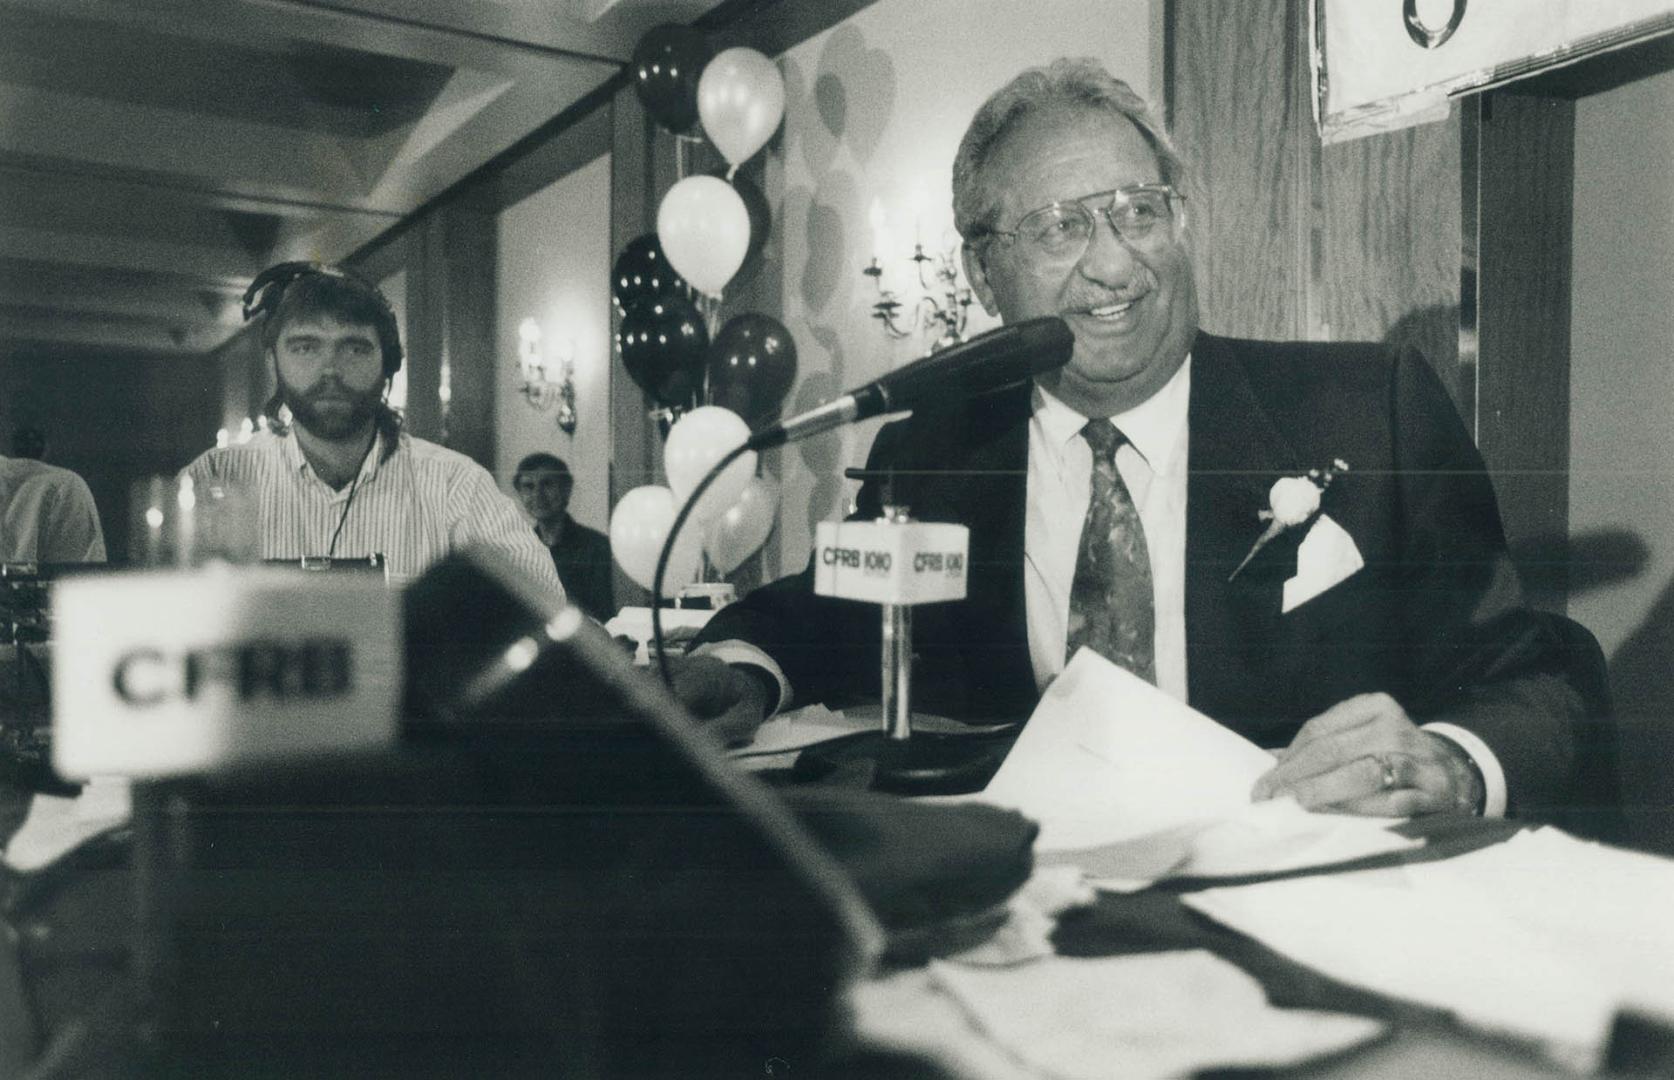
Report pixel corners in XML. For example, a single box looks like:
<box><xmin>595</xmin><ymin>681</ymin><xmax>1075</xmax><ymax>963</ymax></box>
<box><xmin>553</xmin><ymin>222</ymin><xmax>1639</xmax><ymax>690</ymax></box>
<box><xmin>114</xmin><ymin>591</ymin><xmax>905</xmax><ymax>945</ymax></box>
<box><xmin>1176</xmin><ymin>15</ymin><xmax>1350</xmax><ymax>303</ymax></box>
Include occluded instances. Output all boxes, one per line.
<box><xmin>186</xmin><ymin>432</ymin><xmax>564</xmax><ymax>599</ymax></box>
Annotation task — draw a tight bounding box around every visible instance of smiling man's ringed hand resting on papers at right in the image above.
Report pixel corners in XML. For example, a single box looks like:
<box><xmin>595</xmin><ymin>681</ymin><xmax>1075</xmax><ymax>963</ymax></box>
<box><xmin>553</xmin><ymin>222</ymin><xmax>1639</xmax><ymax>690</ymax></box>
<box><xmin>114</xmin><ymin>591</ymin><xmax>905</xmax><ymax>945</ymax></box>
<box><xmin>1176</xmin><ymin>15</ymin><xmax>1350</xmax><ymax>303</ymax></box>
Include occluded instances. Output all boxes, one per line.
<box><xmin>1250</xmin><ymin>693</ymin><xmax>1483</xmax><ymax>817</ymax></box>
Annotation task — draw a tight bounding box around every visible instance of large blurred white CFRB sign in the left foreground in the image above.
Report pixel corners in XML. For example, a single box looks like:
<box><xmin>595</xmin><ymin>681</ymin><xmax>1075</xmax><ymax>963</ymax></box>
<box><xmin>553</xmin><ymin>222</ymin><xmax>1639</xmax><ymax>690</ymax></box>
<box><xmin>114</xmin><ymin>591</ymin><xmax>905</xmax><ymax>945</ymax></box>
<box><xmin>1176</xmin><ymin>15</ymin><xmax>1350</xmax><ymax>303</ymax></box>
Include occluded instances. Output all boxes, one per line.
<box><xmin>52</xmin><ymin>566</ymin><xmax>402</xmax><ymax>779</ymax></box>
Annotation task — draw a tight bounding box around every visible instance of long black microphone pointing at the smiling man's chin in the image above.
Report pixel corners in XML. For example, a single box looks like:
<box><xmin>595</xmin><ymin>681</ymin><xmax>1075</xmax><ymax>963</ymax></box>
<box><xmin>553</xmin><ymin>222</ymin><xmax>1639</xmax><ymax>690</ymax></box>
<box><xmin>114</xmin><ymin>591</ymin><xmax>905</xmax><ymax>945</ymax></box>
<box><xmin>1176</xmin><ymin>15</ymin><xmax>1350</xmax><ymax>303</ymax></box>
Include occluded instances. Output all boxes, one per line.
<box><xmin>745</xmin><ymin>315</ymin><xmax>1075</xmax><ymax>450</ymax></box>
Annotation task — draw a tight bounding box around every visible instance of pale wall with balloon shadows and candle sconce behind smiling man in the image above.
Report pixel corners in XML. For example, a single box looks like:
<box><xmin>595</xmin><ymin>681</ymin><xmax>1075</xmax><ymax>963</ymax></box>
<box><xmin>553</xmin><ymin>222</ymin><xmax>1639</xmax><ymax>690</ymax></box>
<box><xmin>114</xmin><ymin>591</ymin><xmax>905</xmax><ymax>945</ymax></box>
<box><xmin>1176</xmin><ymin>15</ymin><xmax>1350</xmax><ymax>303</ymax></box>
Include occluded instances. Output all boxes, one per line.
<box><xmin>767</xmin><ymin>0</ymin><xmax>1162</xmax><ymax>576</ymax></box>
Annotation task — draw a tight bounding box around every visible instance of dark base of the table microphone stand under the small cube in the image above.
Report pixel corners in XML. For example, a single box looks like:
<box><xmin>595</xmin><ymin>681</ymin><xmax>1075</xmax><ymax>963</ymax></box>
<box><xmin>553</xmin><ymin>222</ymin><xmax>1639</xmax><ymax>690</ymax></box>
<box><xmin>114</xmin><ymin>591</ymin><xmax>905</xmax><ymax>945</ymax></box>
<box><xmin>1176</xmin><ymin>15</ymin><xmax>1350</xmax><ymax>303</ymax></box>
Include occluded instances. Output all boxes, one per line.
<box><xmin>792</xmin><ymin>732</ymin><xmax>1014</xmax><ymax>795</ymax></box>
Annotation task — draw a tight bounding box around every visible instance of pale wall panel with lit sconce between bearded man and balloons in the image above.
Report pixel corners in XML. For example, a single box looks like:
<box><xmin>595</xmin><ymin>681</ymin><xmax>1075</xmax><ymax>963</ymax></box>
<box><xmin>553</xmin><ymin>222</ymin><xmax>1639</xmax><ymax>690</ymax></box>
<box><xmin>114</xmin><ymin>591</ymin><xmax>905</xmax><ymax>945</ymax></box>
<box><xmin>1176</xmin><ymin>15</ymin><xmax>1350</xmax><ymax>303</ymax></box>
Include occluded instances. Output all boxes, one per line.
<box><xmin>490</xmin><ymin>154</ymin><xmax>616</xmax><ymax>531</ymax></box>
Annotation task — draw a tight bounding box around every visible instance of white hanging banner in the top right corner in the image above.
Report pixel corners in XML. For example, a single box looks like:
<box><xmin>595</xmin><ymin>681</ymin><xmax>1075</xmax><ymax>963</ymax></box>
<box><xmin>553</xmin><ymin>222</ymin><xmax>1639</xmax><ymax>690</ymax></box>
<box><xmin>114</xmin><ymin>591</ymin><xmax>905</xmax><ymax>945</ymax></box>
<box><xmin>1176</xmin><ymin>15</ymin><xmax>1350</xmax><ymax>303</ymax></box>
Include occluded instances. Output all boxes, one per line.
<box><xmin>1307</xmin><ymin>0</ymin><xmax>1674</xmax><ymax>142</ymax></box>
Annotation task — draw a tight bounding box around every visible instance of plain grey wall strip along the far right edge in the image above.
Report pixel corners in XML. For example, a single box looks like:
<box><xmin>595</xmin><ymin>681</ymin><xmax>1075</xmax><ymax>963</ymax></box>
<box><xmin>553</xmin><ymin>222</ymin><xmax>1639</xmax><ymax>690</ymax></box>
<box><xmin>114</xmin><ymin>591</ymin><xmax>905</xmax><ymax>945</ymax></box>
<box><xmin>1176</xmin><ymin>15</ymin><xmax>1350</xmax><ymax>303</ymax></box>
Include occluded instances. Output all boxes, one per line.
<box><xmin>1570</xmin><ymin>72</ymin><xmax>1674</xmax><ymax>852</ymax></box>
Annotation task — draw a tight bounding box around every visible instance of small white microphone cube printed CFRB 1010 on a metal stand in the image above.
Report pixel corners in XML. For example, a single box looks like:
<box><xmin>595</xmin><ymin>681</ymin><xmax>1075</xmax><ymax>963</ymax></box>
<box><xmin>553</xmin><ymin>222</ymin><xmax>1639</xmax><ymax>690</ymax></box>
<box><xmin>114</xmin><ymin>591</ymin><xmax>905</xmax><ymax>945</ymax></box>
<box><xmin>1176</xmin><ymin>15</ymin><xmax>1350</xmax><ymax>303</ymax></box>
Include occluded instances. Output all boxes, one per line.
<box><xmin>814</xmin><ymin>521</ymin><xmax>971</xmax><ymax>604</ymax></box>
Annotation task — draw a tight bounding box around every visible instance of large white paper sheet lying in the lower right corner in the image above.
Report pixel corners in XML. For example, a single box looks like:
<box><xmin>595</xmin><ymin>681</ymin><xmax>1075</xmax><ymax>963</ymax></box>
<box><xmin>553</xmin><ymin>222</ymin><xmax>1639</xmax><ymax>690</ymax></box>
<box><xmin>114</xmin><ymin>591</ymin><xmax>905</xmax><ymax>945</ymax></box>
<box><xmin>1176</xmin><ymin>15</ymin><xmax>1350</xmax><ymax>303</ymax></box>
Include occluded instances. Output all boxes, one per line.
<box><xmin>1187</xmin><ymin>829</ymin><xmax>1674</xmax><ymax>1068</ymax></box>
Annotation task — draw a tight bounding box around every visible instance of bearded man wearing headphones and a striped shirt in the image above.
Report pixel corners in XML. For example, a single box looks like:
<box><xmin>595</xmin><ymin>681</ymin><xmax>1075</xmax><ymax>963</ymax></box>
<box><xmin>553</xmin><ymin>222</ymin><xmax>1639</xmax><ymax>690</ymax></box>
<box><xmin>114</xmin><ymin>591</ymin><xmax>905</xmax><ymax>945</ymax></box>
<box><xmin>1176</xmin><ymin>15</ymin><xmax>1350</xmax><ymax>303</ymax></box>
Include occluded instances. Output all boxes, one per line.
<box><xmin>186</xmin><ymin>263</ymin><xmax>564</xmax><ymax>603</ymax></box>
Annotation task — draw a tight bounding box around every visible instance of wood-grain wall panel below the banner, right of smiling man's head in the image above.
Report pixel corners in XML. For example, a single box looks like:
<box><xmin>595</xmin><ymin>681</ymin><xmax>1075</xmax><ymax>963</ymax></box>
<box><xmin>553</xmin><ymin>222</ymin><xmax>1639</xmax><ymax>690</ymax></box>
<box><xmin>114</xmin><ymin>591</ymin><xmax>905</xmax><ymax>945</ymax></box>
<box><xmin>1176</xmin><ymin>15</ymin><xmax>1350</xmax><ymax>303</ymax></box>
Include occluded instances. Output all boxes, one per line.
<box><xmin>1170</xmin><ymin>0</ymin><xmax>1470</xmax><ymax>391</ymax></box>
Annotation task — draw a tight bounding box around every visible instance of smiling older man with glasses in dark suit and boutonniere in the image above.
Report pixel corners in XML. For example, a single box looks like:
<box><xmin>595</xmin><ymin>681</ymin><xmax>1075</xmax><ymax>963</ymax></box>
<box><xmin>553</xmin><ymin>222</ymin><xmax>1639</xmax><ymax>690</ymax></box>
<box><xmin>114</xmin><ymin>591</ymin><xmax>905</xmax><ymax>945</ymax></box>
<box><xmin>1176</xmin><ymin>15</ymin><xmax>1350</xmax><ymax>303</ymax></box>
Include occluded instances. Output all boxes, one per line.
<box><xmin>678</xmin><ymin>60</ymin><xmax>1602</xmax><ymax>815</ymax></box>
